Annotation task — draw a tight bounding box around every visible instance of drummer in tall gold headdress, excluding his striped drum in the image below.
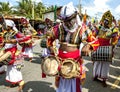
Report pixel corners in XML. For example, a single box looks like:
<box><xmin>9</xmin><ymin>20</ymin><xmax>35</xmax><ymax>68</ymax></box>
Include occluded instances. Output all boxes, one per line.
<box><xmin>93</xmin><ymin>11</ymin><xmax>119</xmax><ymax>87</ymax></box>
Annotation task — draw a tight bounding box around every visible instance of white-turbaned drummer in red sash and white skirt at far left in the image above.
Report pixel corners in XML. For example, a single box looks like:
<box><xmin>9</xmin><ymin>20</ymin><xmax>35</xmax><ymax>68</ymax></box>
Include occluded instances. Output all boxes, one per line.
<box><xmin>0</xmin><ymin>20</ymin><xmax>24</xmax><ymax>89</ymax></box>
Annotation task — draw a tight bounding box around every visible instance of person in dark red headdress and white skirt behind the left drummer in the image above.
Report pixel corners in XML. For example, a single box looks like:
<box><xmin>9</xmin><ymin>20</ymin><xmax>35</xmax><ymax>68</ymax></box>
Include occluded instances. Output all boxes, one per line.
<box><xmin>20</xmin><ymin>18</ymin><xmax>37</xmax><ymax>62</ymax></box>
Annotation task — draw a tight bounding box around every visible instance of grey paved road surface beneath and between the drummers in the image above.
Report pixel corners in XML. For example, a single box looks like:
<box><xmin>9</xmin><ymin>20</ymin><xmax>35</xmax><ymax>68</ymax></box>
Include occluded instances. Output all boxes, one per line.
<box><xmin>0</xmin><ymin>41</ymin><xmax>120</xmax><ymax>92</ymax></box>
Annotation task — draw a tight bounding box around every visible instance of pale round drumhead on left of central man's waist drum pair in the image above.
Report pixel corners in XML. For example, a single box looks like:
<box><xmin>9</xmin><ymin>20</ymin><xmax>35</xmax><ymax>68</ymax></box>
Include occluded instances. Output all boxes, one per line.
<box><xmin>41</xmin><ymin>56</ymin><xmax>60</xmax><ymax>76</ymax></box>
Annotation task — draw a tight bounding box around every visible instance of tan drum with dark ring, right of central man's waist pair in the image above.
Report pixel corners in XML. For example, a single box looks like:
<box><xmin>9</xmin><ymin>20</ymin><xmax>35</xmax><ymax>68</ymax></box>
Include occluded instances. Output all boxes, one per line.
<box><xmin>60</xmin><ymin>59</ymin><xmax>80</xmax><ymax>78</ymax></box>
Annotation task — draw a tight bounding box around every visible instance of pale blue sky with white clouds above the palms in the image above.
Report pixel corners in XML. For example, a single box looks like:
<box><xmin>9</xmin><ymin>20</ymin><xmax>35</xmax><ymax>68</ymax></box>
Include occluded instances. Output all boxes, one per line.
<box><xmin>0</xmin><ymin>0</ymin><xmax>120</xmax><ymax>19</ymax></box>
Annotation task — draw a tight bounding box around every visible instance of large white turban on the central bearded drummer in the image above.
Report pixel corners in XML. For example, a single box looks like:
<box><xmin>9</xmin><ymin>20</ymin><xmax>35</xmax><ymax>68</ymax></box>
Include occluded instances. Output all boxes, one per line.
<box><xmin>60</xmin><ymin>2</ymin><xmax>78</xmax><ymax>19</ymax></box>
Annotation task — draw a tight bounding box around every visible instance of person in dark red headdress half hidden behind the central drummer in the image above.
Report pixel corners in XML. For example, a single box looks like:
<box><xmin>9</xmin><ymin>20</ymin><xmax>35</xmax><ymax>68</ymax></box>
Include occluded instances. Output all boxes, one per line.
<box><xmin>40</xmin><ymin>18</ymin><xmax>53</xmax><ymax>78</ymax></box>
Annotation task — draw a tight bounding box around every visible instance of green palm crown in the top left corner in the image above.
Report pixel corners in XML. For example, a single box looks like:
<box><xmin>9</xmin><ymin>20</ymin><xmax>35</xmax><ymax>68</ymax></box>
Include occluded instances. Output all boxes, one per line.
<box><xmin>0</xmin><ymin>2</ymin><xmax>13</xmax><ymax>15</ymax></box>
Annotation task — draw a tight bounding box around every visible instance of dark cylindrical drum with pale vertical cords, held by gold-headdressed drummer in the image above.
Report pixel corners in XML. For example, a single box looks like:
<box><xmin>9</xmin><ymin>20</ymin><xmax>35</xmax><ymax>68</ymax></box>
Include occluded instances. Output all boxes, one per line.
<box><xmin>91</xmin><ymin>46</ymin><xmax>113</xmax><ymax>62</ymax></box>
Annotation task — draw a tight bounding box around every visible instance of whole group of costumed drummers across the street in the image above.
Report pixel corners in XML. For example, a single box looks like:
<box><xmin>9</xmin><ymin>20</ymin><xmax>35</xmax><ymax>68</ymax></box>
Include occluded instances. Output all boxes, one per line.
<box><xmin>0</xmin><ymin>3</ymin><xmax>120</xmax><ymax>92</ymax></box>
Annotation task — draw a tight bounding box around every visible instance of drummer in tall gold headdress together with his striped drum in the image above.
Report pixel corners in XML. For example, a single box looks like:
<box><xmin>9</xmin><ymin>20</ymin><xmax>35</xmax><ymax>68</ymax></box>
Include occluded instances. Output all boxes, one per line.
<box><xmin>92</xmin><ymin>11</ymin><xmax>118</xmax><ymax>87</ymax></box>
